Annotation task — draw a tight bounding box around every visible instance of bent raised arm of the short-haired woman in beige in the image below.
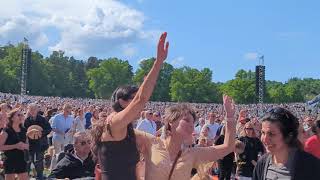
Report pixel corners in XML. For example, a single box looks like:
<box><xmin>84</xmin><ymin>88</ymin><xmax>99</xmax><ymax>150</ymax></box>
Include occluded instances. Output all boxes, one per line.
<box><xmin>192</xmin><ymin>95</ymin><xmax>236</xmax><ymax>164</ymax></box>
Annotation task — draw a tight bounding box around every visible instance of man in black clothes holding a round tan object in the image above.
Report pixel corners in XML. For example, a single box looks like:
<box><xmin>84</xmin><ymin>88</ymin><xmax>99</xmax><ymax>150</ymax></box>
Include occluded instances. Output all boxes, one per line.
<box><xmin>24</xmin><ymin>104</ymin><xmax>51</xmax><ymax>180</ymax></box>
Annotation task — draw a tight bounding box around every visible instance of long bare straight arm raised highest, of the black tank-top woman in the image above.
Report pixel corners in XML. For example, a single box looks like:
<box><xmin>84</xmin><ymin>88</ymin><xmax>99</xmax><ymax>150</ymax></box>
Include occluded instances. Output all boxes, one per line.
<box><xmin>110</xmin><ymin>32</ymin><xmax>169</xmax><ymax>131</ymax></box>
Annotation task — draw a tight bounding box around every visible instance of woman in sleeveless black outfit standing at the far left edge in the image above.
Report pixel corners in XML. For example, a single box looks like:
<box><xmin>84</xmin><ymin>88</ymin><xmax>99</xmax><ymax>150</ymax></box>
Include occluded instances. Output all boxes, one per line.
<box><xmin>0</xmin><ymin>109</ymin><xmax>29</xmax><ymax>180</ymax></box>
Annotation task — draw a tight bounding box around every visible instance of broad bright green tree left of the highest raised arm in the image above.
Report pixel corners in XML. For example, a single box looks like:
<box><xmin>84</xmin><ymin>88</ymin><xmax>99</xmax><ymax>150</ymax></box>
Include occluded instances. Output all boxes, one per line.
<box><xmin>87</xmin><ymin>58</ymin><xmax>133</xmax><ymax>98</ymax></box>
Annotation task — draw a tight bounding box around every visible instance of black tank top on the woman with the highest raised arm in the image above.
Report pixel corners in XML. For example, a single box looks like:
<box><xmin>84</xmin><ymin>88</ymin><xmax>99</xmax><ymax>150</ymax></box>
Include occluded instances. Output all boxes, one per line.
<box><xmin>98</xmin><ymin>124</ymin><xmax>140</xmax><ymax>180</ymax></box>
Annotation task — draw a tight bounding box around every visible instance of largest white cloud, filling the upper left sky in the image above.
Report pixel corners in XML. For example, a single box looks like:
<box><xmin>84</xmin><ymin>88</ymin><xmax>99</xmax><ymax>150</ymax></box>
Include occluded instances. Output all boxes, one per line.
<box><xmin>0</xmin><ymin>0</ymin><xmax>160</xmax><ymax>56</ymax></box>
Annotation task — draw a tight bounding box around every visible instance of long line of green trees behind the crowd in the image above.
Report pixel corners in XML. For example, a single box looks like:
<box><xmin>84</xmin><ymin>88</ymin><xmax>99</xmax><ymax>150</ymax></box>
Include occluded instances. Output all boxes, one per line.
<box><xmin>0</xmin><ymin>44</ymin><xmax>320</xmax><ymax>104</ymax></box>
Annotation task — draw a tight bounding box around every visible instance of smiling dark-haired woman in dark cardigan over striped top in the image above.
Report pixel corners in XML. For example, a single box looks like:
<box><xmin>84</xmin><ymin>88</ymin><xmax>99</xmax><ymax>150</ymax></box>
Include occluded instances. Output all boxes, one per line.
<box><xmin>253</xmin><ymin>107</ymin><xmax>320</xmax><ymax>180</ymax></box>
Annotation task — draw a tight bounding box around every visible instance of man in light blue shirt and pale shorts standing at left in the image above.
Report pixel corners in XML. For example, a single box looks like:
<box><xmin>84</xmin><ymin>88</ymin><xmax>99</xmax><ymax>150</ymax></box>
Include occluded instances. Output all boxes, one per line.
<box><xmin>51</xmin><ymin>104</ymin><xmax>74</xmax><ymax>154</ymax></box>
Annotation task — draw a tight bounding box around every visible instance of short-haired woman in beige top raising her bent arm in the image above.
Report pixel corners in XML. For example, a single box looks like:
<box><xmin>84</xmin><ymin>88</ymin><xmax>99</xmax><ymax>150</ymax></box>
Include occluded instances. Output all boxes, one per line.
<box><xmin>136</xmin><ymin>96</ymin><xmax>236</xmax><ymax>180</ymax></box>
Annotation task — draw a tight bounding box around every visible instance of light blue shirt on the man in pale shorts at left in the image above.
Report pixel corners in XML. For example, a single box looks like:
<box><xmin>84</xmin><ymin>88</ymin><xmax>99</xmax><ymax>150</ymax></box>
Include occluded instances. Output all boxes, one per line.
<box><xmin>51</xmin><ymin>113</ymin><xmax>74</xmax><ymax>143</ymax></box>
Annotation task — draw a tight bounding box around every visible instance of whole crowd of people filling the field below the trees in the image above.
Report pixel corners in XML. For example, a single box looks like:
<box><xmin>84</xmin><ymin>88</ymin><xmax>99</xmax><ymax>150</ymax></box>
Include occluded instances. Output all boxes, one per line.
<box><xmin>0</xmin><ymin>33</ymin><xmax>320</xmax><ymax>180</ymax></box>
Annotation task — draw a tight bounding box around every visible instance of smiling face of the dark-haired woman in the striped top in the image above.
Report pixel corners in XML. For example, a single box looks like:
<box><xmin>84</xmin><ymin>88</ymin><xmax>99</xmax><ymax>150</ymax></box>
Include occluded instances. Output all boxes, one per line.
<box><xmin>261</xmin><ymin>121</ymin><xmax>288</xmax><ymax>154</ymax></box>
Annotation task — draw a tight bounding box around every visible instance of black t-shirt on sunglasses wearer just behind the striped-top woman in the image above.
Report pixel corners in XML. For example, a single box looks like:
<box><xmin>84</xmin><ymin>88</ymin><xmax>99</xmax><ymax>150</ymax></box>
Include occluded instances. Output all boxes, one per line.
<box><xmin>237</xmin><ymin>136</ymin><xmax>264</xmax><ymax>177</ymax></box>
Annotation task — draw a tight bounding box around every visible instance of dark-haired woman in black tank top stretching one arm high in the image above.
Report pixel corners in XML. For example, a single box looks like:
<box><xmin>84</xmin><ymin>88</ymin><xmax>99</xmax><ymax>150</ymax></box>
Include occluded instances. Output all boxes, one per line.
<box><xmin>92</xmin><ymin>33</ymin><xmax>169</xmax><ymax>180</ymax></box>
